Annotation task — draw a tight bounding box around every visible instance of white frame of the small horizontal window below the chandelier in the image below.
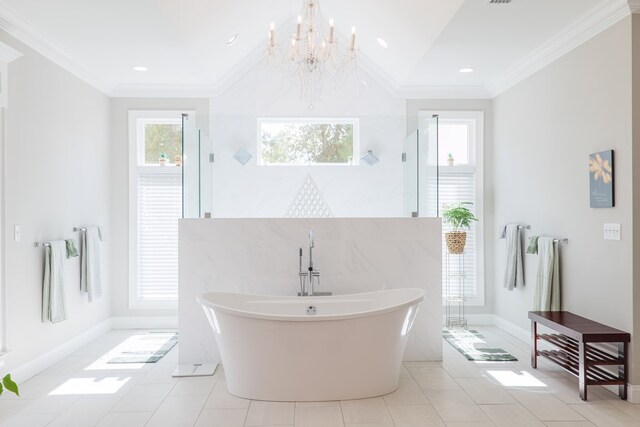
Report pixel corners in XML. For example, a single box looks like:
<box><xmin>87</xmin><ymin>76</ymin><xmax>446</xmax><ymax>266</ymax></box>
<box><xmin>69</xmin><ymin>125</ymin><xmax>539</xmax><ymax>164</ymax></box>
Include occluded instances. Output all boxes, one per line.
<box><xmin>256</xmin><ymin>117</ymin><xmax>360</xmax><ymax>167</ymax></box>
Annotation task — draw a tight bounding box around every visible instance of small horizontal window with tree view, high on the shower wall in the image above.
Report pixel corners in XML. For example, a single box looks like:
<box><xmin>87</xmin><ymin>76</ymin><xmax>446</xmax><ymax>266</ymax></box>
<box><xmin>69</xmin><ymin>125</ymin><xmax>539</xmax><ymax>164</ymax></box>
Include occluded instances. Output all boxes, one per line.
<box><xmin>257</xmin><ymin>119</ymin><xmax>359</xmax><ymax>166</ymax></box>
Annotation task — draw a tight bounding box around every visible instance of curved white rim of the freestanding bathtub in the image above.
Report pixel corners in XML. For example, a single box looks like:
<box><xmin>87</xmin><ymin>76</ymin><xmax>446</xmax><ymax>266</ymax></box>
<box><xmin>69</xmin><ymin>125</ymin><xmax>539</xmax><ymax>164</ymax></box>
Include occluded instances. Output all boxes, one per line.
<box><xmin>196</xmin><ymin>288</ymin><xmax>426</xmax><ymax>322</ymax></box>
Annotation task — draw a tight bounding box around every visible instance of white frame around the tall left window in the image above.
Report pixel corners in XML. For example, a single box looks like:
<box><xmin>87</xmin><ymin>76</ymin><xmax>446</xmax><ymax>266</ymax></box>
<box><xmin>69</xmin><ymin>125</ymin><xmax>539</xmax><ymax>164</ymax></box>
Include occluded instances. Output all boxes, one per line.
<box><xmin>129</xmin><ymin>110</ymin><xmax>195</xmax><ymax>309</ymax></box>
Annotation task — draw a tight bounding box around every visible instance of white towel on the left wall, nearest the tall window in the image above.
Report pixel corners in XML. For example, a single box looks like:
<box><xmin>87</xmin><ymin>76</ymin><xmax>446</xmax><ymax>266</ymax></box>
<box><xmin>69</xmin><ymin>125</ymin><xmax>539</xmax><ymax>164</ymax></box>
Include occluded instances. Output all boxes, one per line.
<box><xmin>80</xmin><ymin>225</ymin><xmax>102</xmax><ymax>302</ymax></box>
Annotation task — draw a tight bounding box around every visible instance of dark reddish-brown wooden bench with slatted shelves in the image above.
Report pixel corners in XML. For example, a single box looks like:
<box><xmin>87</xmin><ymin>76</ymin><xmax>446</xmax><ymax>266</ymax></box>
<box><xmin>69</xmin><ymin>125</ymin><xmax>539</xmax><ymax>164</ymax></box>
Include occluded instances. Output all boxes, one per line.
<box><xmin>529</xmin><ymin>311</ymin><xmax>631</xmax><ymax>400</ymax></box>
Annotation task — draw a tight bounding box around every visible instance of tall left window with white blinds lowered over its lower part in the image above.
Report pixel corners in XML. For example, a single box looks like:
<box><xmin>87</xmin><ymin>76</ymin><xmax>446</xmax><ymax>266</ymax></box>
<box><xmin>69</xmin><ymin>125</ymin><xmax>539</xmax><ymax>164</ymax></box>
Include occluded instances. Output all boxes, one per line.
<box><xmin>129</xmin><ymin>111</ymin><xmax>188</xmax><ymax>308</ymax></box>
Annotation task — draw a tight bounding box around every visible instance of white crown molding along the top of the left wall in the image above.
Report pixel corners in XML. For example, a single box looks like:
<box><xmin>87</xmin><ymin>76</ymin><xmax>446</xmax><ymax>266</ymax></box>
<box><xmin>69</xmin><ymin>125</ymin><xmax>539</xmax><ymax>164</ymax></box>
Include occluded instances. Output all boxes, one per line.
<box><xmin>0</xmin><ymin>0</ymin><xmax>114</xmax><ymax>95</ymax></box>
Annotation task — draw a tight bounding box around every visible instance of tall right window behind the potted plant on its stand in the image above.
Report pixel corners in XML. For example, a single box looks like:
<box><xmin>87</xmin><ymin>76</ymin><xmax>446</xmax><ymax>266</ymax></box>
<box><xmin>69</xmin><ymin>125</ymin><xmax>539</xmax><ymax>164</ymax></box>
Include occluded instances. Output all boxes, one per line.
<box><xmin>424</xmin><ymin>111</ymin><xmax>484</xmax><ymax>305</ymax></box>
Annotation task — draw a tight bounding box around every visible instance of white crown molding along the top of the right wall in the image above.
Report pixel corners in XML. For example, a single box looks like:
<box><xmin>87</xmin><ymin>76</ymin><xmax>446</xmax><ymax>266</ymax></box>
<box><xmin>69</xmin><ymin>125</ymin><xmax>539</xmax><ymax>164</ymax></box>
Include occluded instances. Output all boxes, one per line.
<box><xmin>486</xmin><ymin>0</ymin><xmax>640</xmax><ymax>98</ymax></box>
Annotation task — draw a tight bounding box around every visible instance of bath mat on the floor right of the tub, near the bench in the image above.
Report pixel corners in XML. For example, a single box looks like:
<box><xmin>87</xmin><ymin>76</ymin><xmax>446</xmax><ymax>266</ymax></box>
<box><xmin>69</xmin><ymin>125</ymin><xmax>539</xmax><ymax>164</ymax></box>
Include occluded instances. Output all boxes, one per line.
<box><xmin>442</xmin><ymin>328</ymin><xmax>518</xmax><ymax>362</ymax></box>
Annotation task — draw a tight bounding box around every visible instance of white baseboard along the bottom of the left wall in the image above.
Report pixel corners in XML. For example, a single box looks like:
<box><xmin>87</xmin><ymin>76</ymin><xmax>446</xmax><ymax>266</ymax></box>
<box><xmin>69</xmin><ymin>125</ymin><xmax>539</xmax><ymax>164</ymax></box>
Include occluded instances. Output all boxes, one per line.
<box><xmin>11</xmin><ymin>319</ymin><xmax>112</xmax><ymax>383</ymax></box>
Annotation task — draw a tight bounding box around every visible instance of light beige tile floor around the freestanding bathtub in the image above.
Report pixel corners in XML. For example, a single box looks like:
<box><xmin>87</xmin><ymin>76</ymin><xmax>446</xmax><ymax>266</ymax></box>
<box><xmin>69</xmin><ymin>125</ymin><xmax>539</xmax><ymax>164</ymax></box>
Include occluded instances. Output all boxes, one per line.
<box><xmin>0</xmin><ymin>327</ymin><xmax>640</xmax><ymax>427</ymax></box>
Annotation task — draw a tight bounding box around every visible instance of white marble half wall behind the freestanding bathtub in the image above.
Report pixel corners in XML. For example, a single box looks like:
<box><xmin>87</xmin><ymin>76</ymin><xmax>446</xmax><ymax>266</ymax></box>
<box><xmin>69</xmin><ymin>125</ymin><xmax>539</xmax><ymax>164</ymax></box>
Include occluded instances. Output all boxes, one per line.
<box><xmin>179</xmin><ymin>218</ymin><xmax>442</xmax><ymax>370</ymax></box>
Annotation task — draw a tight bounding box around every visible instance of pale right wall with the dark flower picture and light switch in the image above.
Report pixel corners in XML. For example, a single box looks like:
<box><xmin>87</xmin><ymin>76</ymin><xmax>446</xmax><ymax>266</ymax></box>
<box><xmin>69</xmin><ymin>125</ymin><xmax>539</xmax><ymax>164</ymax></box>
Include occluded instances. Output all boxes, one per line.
<box><xmin>486</xmin><ymin>18</ymin><xmax>637</xmax><ymax>346</ymax></box>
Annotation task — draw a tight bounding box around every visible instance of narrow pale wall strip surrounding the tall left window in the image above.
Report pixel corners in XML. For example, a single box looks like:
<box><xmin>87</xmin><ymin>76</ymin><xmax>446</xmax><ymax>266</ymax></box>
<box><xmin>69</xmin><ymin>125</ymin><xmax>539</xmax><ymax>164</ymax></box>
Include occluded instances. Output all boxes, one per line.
<box><xmin>109</xmin><ymin>98</ymin><xmax>209</xmax><ymax>317</ymax></box>
